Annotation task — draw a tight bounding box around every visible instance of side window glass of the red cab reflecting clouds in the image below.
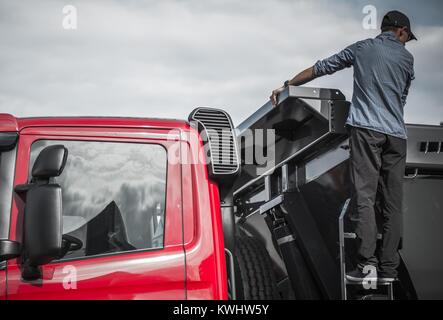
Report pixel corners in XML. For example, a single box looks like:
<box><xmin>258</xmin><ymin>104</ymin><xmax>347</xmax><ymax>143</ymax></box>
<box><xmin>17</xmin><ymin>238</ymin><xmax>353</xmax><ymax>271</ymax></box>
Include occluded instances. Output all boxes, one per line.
<box><xmin>30</xmin><ymin>140</ymin><xmax>167</xmax><ymax>258</ymax></box>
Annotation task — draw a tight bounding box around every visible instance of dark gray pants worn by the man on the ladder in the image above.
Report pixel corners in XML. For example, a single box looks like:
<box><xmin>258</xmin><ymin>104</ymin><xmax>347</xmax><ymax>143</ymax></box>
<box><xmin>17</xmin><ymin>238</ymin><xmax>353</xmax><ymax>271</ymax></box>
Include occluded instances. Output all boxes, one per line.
<box><xmin>348</xmin><ymin>127</ymin><xmax>406</xmax><ymax>277</ymax></box>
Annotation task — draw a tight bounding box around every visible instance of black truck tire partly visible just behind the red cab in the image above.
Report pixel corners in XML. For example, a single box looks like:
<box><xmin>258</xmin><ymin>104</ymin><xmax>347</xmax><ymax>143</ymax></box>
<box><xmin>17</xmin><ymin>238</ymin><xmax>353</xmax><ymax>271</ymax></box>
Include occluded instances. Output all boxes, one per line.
<box><xmin>235</xmin><ymin>236</ymin><xmax>280</xmax><ymax>300</ymax></box>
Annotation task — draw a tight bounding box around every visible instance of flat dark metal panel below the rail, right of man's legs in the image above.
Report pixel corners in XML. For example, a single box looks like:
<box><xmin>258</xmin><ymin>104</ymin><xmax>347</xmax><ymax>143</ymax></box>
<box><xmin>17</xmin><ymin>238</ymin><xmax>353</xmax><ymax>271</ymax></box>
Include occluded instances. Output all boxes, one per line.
<box><xmin>401</xmin><ymin>176</ymin><xmax>443</xmax><ymax>299</ymax></box>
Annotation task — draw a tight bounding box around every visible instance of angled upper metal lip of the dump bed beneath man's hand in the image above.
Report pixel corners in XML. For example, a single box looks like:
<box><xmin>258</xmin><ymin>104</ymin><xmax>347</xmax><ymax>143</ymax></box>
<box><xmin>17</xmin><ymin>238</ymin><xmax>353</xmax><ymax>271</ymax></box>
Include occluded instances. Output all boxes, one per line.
<box><xmin>234</xmin><ymin>87</ymin><xmax>349</xmax><ymax>192</ymax></box>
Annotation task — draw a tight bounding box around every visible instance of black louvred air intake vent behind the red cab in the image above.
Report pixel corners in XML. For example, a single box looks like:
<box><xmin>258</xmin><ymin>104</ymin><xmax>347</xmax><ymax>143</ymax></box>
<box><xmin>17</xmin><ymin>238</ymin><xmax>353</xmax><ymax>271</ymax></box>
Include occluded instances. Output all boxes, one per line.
<box><xmin>189</xmin><ymin>108</ymin><xmax>240</xmax><ymax>176</ymax></box>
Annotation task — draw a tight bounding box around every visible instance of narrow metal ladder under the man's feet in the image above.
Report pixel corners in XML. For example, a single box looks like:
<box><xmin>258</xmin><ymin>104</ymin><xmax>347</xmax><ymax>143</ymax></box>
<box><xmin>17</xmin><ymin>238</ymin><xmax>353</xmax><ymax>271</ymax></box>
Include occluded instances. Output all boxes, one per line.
<box><xmin>338</xmin><ymin>198</ymin><xmax>394</xmax><ymax>300</ymax></box>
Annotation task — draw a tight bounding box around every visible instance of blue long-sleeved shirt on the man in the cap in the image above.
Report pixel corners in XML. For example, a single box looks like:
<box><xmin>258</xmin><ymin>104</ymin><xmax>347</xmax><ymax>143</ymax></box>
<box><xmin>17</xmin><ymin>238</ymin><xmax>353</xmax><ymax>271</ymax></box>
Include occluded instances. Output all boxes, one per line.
<box><xmin>314</xmin><ymin>31</ymin><xmax>414</xmax><ymax>139</ymax></box>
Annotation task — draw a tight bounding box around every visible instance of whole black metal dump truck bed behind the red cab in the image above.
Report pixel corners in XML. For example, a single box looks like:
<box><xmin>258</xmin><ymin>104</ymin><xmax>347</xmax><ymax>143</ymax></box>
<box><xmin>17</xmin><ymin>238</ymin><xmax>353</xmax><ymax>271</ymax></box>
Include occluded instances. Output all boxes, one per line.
<box><xmin>234</xmin><ymin>87</ymin><xmax>443</xmax><ymax>299</ymax></box>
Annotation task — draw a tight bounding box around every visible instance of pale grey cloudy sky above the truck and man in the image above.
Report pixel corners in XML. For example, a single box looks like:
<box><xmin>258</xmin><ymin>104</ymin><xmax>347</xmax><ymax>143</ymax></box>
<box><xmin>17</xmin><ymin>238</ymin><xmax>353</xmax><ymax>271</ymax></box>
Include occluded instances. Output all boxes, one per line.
<box><xmin>0</xmin><ymin>0</ymin><xmax>443</xmax><ymax>124</ymax></box>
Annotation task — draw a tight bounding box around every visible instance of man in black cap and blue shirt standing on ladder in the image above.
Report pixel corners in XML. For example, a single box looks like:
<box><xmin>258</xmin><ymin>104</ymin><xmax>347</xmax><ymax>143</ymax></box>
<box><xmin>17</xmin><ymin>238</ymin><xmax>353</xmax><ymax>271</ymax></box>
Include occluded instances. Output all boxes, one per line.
<box><xmin>271</xmin><ymin>11</ymin><xmax>417</xmax><ymax>281</ymax></box>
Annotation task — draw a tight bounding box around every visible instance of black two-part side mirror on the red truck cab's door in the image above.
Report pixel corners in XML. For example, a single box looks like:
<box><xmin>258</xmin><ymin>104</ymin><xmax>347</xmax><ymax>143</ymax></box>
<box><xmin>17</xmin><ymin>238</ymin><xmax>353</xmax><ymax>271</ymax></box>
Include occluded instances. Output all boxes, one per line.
<box><xmin>16</xmin><ymin>145</ymin><xmax>68</xmax><ymax>280</ymax></box>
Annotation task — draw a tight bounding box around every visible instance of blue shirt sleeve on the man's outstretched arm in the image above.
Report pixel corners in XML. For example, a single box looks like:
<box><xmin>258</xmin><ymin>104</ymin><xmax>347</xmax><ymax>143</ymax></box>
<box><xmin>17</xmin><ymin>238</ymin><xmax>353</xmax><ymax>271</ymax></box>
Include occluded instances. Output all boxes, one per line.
<box><xmin>314</xmin><ymin>43</ymin><xmax>357</xmax><ymax>77</ymax></box>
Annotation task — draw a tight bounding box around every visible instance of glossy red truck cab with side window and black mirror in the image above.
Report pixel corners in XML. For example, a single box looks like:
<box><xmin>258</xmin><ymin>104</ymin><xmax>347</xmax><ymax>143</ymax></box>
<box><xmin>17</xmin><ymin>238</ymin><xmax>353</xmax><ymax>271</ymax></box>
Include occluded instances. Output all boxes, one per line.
<box><xmin>0</xmin><ymin>111</ymin><xmax>238</xmax><ymax>299</ymax></box>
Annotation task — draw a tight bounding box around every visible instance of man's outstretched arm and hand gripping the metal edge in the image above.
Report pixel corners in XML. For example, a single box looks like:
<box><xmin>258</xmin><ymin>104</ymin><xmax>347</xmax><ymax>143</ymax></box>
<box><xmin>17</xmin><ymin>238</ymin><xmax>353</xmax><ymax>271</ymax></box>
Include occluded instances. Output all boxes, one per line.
<box><xmin>270</xmin><ymin>43</ymin><xmax>357</xmax><ymax>106</ymax></box>
